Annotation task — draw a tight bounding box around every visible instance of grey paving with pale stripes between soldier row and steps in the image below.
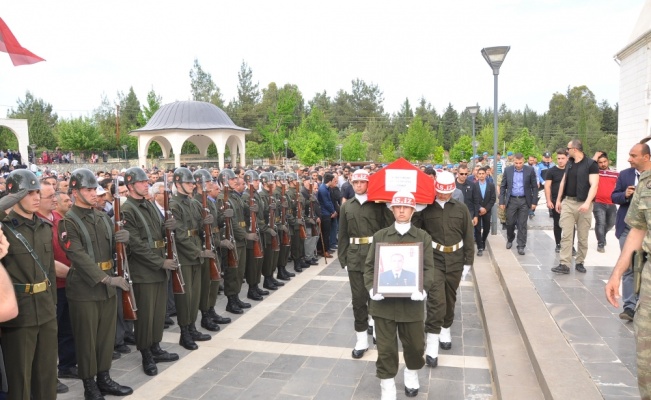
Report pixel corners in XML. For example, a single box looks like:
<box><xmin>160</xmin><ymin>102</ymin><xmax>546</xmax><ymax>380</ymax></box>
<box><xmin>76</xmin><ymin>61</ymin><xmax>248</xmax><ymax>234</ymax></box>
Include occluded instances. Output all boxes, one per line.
<box><xmin>58</xmin><ymin>253</ymin><xmax>494</xmax><ymax>400</ymax></box>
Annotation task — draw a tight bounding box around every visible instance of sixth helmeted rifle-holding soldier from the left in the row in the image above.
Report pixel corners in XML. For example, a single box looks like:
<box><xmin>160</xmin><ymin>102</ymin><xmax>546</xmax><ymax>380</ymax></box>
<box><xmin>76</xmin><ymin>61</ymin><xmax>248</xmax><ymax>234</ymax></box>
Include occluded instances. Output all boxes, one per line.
<box><xmin>217</xmin><ymin>168</ymin><xmax>253</xmax><ymax>314</ymax></box>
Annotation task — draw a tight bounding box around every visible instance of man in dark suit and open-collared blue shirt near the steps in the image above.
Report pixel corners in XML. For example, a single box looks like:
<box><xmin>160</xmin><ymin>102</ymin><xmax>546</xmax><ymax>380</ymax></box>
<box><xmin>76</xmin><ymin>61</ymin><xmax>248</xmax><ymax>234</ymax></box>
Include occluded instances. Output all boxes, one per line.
<box><xmin>500</xmin><ymin>153</ymin><xmax>538</xmax><ymax>255</ymax></box>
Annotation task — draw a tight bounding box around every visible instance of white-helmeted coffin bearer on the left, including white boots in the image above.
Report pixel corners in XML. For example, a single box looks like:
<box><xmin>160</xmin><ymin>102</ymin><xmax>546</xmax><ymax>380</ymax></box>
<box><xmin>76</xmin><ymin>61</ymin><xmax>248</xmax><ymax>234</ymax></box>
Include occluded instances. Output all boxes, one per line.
<box><xmin>339</xmin><ymin>169</ymin><xmax>393</xmax><ymax>358</ymax></box>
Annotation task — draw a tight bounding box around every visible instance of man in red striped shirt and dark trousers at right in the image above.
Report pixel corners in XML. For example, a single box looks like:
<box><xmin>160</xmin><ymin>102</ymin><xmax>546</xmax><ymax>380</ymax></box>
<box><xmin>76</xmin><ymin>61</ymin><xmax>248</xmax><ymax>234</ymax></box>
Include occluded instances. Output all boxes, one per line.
<box><xmin>592</xmin><ymin>151</ymin><xmax>619</xmax><ymax>253</ymax></box>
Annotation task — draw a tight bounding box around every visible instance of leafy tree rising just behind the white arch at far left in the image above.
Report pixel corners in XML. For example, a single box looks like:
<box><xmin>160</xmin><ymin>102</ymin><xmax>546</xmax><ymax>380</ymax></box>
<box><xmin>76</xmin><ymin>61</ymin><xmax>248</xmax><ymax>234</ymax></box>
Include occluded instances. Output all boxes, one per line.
<box><xmin>7</xmin><ymin>91</ymin><xmax>58</xmax><ymax>150</ymax></box>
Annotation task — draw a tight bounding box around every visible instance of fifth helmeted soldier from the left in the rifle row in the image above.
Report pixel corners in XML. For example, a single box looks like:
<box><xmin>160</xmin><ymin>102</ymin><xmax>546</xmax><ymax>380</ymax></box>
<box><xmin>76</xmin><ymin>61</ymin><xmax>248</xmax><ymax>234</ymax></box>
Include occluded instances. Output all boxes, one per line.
<box><xmin>193</xmin><ymin>169</ymin><xmax>231</xmax><ymax>332</ymax></box>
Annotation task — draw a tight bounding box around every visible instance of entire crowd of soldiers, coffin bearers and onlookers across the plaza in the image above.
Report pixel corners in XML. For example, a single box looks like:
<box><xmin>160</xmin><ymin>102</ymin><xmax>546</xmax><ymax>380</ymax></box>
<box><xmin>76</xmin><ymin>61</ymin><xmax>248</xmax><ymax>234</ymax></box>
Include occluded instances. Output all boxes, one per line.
<box><xmin>0</xmin><ymin>140</ymin><xmax>651</xmax><ymax>399</ymax></box>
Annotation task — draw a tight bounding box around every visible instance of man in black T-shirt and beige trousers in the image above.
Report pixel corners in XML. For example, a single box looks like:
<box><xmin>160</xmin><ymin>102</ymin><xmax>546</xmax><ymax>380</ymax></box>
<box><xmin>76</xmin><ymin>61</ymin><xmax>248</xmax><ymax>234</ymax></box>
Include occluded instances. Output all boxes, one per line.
<box><xmin>552</xmin><ymin>139</ymin><xmax>599</xmax><ymax>274</ymax></box>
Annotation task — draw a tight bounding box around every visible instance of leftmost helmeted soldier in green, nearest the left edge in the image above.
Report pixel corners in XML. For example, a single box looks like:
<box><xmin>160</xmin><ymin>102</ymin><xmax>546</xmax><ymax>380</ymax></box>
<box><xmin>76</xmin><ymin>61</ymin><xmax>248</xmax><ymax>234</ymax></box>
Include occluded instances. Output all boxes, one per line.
<box><xmin>0</xmin><ymin>169</ymin><xmax>57</xmax><ymax>400</ymax></box>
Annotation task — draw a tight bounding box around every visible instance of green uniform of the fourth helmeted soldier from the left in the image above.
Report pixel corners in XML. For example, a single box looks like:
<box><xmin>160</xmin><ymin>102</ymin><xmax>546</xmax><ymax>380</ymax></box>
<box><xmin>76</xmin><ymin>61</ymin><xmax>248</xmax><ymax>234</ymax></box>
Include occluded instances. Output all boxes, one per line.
<box><xmin>170</xmin><ymin>193</ymin><xmax>203</xmax><ymax>326</ymax></box>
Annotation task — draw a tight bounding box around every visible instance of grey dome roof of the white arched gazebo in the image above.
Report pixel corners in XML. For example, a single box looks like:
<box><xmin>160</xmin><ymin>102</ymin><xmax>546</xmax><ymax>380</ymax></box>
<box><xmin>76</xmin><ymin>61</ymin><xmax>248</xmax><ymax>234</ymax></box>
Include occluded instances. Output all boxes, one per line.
<box><xmin>132</xmin><ymin>101</ymin><xmax>250</xmax><ymax>132</ymax></box>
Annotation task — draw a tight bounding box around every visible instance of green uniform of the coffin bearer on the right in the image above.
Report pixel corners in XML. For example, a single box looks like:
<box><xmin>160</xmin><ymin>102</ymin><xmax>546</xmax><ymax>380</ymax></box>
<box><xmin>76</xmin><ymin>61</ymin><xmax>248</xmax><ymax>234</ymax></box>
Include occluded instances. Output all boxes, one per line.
<box><xmin>413</xmin><ymin>199</ymin><xmax>475</xmax><ymax>334</ymax></box>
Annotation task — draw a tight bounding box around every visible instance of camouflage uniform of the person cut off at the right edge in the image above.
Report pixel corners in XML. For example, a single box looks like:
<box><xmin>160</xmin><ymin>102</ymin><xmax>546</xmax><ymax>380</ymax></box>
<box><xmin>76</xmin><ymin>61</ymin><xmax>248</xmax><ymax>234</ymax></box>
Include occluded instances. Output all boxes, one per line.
<box><xmin>624</xmin><ymin>171</ymin><xmax>651</xmax><ymax>399</ymax></box>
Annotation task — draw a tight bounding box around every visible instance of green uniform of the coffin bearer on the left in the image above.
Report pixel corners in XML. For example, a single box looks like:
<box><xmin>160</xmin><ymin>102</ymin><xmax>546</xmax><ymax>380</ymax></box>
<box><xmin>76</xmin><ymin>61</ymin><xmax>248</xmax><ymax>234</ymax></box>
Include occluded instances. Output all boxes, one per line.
<box><xmin>338</xmin><ymin>197</ymin><xmax>394</xmax><ymax>332</ymax></box>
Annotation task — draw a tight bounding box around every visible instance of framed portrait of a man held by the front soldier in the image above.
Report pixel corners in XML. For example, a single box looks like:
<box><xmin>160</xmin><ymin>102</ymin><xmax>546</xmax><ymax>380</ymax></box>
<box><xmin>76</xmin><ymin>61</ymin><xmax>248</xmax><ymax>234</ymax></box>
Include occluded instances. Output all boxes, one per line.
<box><xmin>373</xmin><ymin>243</ymin><xmax>423</xmax><ymax>297</ymax></box>
